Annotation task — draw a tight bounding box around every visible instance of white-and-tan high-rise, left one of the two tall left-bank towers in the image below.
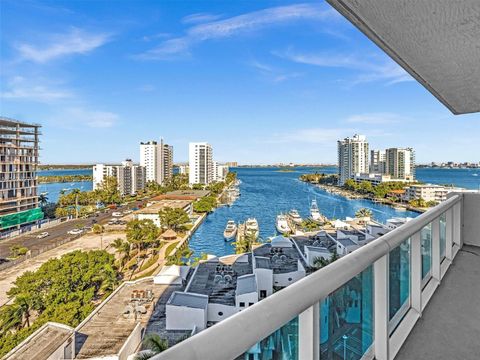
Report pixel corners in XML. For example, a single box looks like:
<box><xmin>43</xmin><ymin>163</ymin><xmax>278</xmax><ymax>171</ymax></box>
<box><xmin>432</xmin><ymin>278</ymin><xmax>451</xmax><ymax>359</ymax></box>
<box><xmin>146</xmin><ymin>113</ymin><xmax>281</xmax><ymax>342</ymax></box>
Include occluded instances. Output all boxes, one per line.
<box><xmin>140</xmin><ymin>139</ymin><xmax>173</xmax><ymax>184</ymax></box>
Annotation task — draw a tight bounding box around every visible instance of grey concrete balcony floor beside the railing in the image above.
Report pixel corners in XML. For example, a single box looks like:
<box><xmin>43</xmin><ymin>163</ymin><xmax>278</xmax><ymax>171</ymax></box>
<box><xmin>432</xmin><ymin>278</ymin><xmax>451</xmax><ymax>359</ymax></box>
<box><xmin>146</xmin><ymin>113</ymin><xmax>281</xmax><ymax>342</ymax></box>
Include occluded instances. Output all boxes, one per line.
<box><xmin>395</xmin><ymin>246</ymin><xmax>480</xmax><ymax>360</ymax></box>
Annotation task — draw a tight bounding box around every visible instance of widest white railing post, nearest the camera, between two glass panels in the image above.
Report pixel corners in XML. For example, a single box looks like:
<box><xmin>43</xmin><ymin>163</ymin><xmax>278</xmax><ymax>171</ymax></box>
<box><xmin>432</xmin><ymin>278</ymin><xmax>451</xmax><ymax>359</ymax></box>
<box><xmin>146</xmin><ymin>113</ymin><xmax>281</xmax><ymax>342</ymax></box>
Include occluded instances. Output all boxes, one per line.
<box><xmin>298</xmin><ymin>304</ymin><xmax>320</xmax><ymax>360</ymax></box>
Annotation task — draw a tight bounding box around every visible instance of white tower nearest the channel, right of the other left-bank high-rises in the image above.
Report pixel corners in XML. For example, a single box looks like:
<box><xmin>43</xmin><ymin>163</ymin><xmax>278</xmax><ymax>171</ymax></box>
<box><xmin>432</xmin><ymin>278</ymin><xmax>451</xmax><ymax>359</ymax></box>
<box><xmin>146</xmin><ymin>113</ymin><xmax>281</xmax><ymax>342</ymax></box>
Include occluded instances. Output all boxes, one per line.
<box><xmin>188</xmin><ymin>142</ymin><xmax>215</xmax><ymax>184</ymax></box>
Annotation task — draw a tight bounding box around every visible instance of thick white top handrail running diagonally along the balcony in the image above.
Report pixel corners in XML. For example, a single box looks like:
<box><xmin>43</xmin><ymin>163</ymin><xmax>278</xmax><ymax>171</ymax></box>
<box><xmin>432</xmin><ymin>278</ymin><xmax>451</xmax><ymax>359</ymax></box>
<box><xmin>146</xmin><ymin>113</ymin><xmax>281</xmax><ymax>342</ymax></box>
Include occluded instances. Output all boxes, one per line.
<box><xmin>152</xmin><ymin>195</ymin><xmax>462</xmax><ymax>360</ymax></box>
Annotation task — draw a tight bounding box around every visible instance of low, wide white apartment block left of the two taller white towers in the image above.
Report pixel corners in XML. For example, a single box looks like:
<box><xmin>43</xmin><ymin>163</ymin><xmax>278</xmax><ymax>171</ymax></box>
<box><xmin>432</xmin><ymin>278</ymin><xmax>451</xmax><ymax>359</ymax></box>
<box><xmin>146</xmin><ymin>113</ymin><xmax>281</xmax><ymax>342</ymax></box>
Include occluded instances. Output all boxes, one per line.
<box><xmin>93</xmin><ymin>159</ymin><xmax>145</xmax><ymax>195</ymax></box>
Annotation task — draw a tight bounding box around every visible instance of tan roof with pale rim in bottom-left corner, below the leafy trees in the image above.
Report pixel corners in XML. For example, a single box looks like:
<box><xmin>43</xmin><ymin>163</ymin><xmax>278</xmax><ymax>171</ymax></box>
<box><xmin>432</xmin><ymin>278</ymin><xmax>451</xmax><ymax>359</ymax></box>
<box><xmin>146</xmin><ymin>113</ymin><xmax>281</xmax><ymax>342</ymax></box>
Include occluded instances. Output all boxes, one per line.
<box><xmin>7</xmin><ymin>322</ymin><xmax>74</xmax><ymax>360</ymax></box>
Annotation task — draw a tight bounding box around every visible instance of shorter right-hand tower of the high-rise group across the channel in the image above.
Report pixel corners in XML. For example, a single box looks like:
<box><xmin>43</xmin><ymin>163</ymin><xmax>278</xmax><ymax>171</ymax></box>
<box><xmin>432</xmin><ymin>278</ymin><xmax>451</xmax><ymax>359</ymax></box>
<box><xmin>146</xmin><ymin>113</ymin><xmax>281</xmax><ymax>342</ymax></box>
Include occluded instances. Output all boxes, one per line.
<box><xmin>385</xmin><ymin>148</ymin><xmax>415</xmax><ymax>181</ymax></box>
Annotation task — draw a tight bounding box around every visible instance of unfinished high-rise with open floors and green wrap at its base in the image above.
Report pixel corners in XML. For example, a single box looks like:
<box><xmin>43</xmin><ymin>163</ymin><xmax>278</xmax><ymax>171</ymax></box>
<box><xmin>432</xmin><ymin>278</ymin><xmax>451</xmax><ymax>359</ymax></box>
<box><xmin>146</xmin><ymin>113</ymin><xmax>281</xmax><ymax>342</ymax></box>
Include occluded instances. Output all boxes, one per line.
<box><xmin>0</xmin><ymin>117</ymin><xmax>43</xmax><ymax>230</ymax></box>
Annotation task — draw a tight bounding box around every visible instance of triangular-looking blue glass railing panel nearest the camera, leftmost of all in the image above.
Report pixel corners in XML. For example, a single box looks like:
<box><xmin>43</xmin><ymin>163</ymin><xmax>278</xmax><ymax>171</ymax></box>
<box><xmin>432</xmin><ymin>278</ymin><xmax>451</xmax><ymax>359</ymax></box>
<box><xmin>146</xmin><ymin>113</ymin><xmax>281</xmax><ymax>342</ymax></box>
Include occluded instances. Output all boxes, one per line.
<box><xmin>236</xmin><ymin>317</ymin><xmax>298</xmax><ymax>360</ymax></box>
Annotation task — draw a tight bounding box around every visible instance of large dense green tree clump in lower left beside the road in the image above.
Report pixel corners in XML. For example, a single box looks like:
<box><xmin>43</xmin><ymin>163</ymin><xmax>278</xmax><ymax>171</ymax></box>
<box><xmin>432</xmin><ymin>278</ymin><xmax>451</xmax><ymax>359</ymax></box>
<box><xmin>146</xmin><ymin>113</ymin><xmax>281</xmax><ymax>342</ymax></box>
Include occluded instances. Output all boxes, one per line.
<box><xmin>0</xmin><ymin>250</ymin><xmax>118</xmax><ymax>357</ymax></box>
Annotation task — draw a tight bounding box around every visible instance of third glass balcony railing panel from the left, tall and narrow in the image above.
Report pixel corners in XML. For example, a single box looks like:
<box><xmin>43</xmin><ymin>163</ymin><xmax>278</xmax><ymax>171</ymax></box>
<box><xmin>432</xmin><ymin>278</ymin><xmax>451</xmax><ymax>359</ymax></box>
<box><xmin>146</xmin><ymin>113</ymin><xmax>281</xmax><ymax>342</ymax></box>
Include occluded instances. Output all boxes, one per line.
<box><xmin>388</xmin><ymin>239</ymin><xmax>411</xmax><ymax>330</ymax></box>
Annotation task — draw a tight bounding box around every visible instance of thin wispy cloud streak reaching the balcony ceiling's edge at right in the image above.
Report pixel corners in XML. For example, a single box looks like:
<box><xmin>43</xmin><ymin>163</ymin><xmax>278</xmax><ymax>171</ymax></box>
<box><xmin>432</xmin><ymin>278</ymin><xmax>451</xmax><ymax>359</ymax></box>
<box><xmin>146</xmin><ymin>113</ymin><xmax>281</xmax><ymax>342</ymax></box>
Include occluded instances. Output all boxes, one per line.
<box><xmin>274</xmin><ymin>49</ymin><xmax>413</xmax><ymax>85</ymax></box>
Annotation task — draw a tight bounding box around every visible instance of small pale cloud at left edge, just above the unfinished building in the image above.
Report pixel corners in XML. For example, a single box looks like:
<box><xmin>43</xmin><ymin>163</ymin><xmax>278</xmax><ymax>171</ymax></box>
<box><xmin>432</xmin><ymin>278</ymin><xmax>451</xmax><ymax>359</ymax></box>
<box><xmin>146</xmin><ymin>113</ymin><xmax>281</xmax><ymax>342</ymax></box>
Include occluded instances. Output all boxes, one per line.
<box><xmin>0</xmin><ymin>76</ymin><xmax>73</xmax><ymax>103</ymax></box>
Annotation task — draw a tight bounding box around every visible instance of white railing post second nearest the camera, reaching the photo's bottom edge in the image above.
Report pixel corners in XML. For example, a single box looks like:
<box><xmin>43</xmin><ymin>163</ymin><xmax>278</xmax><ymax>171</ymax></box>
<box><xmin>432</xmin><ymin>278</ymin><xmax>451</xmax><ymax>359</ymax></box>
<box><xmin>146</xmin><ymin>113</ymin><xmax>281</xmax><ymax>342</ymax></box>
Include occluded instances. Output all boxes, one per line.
<box><xmin>373</xmin><ymin>254</ymin><xmax>389</xmax><ymax>360</ymax></box>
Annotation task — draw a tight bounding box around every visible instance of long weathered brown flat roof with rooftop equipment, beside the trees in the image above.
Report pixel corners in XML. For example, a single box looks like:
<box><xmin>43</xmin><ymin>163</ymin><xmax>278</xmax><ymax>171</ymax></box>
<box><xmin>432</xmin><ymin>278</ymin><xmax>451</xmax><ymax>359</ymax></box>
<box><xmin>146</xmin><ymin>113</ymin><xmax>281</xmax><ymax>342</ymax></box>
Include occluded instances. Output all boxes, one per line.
<box><xmin>75</xmin><ymin>279</ymin><xmax>168</xmax><ymax>359</ymax></box>
